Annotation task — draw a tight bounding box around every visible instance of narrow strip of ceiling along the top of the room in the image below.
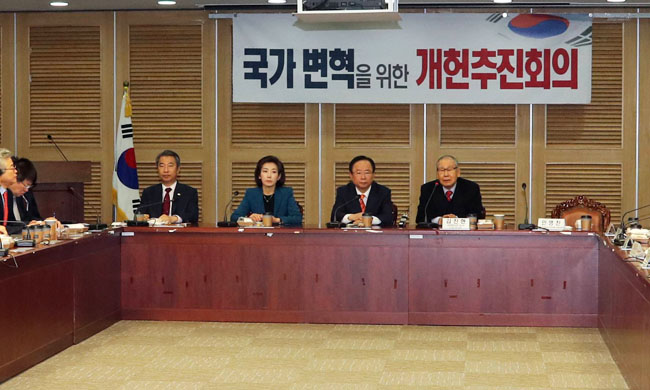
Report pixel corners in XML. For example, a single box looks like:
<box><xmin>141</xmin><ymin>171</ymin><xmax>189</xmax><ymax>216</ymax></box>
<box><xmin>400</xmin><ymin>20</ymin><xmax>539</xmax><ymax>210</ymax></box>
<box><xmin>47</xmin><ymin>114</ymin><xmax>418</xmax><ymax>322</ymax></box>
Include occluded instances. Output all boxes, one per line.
<box><xmin>0</xmin><ymin>0</ymin><xmax>650</xmax><ymax>12</ymax></box>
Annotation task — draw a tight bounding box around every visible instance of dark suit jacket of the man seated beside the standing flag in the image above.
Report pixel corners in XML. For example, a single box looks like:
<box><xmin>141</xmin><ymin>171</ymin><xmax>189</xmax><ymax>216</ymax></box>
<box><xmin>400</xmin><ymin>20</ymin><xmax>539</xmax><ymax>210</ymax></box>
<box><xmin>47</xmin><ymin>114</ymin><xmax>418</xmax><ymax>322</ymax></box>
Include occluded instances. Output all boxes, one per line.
<box><xmin>138</xmin><ymin>182</ymin><xmax>199</xmax><ymax>223</ymax></box>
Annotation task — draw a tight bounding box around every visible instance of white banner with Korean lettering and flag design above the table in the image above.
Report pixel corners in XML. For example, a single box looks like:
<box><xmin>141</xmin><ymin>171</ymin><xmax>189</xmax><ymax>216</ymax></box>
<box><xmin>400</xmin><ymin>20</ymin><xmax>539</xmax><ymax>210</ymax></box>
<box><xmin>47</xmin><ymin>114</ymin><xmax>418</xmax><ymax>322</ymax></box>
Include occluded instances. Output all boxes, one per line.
<box><xmin>233</xmin><ymin>13</ymin><xmax>591</xmax><ymax>104</ymax></box>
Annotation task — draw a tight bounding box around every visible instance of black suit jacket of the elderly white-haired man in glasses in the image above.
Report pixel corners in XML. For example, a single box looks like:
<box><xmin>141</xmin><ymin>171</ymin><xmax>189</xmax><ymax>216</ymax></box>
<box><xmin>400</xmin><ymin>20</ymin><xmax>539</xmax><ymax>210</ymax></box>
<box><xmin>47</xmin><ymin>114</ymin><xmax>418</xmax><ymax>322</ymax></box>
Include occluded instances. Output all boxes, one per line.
<box><xmin>415</xmin><ymin>177</ymin><xmax>485</xmax><ymax>222</ymax></box>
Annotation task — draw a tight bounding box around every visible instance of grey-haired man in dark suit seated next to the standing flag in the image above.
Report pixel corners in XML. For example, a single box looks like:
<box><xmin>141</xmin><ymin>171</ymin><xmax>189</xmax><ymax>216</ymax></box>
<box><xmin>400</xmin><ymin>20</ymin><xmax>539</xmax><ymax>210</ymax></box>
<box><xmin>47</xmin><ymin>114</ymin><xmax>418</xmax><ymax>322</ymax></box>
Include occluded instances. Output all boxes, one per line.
<box><xmin>138</xmin><ymin>150</ymin><xmax>199</xmax><ymax>223</ymax></box>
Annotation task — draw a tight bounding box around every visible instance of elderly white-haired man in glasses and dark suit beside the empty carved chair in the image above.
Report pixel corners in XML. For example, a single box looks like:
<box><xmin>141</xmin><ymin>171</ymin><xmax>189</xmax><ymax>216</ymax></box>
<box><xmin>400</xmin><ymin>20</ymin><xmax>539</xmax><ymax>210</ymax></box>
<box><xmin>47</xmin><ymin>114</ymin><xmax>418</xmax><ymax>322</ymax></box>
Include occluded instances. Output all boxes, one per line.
<box><xmin>416</xmin><ymin>155</ymin><xmax>485</xmax><ymax>223</ymax></box>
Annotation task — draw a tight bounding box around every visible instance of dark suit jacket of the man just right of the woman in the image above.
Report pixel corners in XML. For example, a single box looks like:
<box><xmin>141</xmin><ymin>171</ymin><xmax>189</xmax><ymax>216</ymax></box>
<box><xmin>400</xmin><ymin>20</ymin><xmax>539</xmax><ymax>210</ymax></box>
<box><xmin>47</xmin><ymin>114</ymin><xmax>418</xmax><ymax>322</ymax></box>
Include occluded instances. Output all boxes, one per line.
<box><xmin>331</xmin><ymin>182</ymin><xmax>393</xmax><ymax>226</ymax></box>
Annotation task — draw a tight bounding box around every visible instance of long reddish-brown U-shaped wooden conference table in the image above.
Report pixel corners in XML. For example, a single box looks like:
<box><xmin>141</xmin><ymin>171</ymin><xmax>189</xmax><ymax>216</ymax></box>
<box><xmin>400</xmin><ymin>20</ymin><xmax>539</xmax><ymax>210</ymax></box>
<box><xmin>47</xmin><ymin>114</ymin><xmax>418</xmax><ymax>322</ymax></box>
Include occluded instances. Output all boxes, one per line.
<box><xmin>0</xmin><ymin>226</ymin><xmax>650</xmax><ymax>389</ymax></box>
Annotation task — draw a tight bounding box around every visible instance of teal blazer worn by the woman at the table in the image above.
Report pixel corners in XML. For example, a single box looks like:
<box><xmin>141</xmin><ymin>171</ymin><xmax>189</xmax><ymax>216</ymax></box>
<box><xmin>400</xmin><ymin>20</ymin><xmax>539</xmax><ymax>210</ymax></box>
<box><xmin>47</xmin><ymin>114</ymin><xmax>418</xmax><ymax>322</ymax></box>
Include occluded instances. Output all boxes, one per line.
<box><xmin>230</xmin><ymin>187</ymin><xmax>302</xmax><ymax>226</ymax></box>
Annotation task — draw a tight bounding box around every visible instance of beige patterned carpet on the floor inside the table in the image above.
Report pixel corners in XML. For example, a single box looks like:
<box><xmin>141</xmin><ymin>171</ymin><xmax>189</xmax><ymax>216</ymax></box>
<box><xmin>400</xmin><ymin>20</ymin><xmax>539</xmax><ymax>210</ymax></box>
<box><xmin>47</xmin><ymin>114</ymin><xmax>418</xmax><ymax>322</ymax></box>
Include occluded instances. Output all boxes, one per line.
<box><xmin>0</xmin><ymin>321</ymin><xmax>628</xmax><ymax>390</ymax></box>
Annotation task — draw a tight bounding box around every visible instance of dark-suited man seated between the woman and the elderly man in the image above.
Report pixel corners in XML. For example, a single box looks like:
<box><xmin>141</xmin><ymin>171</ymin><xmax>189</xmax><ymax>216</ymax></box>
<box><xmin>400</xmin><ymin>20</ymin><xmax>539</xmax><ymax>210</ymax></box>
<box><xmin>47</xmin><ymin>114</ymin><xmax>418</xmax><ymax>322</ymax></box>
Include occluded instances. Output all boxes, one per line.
<box><xmin>332</xmin><ymin>156</ymin><xmax>393</xmax><ymax>226</ymax></box>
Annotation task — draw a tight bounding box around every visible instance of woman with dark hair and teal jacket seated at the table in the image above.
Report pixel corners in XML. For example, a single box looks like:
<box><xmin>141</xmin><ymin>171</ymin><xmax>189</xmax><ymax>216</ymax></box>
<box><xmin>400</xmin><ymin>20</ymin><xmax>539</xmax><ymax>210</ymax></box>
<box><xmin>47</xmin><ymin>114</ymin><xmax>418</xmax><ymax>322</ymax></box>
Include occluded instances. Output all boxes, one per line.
<box><xmin>230</xmin><ymin>156</ymin><xmax>302</xmax><ymax>225</ymax></box>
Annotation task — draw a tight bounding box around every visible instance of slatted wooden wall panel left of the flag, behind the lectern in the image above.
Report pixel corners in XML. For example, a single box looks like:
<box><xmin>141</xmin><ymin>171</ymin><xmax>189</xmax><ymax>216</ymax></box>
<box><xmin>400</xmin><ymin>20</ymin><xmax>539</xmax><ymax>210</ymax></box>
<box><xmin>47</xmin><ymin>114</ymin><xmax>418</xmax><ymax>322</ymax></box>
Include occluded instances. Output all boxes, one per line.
<box><xmin>16</xmin><ymin>12</ymin><xmax>114</xmax><ymax>222</ymax></box>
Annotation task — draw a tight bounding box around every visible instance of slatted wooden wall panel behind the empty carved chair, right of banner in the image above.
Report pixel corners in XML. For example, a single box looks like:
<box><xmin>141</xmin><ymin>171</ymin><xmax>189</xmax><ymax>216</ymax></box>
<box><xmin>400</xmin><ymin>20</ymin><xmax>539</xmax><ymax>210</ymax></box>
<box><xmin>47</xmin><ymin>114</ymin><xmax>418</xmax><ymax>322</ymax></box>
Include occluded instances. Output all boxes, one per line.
<box><xmin>533</xmin><ymin>21</ymin><xmax>636</xmax><ymax>221</ymax></box>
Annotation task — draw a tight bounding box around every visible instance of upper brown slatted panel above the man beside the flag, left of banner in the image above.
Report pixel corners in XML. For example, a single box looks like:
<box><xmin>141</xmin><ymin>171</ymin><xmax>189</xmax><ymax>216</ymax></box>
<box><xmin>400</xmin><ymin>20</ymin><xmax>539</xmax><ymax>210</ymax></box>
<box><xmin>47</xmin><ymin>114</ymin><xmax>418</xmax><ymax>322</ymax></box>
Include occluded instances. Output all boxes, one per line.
<box><xmin>129</xmin><ymin>24</ymin><xmax>203</xmax><ymax>147</ymax></box>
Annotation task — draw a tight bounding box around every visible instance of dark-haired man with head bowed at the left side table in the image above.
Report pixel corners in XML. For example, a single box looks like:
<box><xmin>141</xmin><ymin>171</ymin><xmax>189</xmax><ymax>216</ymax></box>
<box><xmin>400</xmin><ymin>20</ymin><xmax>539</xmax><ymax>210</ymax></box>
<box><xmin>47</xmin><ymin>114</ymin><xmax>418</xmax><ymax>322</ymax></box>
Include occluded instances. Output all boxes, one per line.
<box><xmin>9</xmin><ymin>157</ymin><xmax>43</xmax><ymax>223</ymax></box>
